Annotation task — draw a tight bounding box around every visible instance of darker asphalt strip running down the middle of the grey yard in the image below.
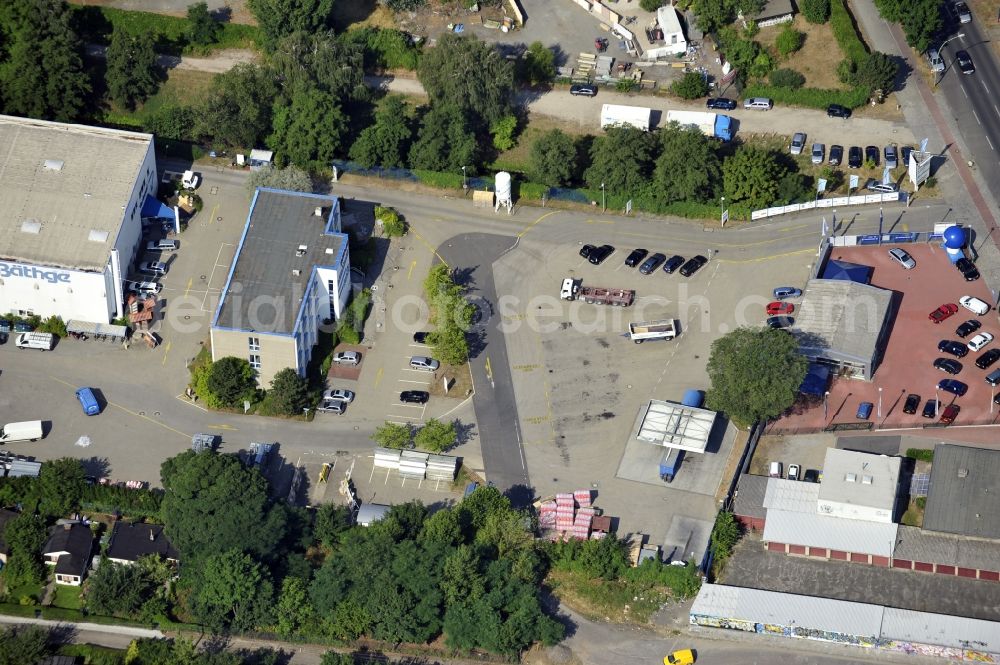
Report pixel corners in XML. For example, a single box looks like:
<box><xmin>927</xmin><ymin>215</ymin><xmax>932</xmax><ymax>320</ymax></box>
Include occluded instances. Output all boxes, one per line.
<box><xmin>437</xmin><ymin>233</ymin><xmax>532</xmax><ymax>498</ymax></box>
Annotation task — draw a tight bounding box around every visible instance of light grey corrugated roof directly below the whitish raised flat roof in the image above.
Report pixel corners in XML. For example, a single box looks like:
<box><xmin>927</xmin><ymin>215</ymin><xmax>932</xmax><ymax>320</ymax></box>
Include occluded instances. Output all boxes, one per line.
<box><xmin>763</xmin><ymin>508</ymin><xmax>897</xmax><ymax>556</ymax></box>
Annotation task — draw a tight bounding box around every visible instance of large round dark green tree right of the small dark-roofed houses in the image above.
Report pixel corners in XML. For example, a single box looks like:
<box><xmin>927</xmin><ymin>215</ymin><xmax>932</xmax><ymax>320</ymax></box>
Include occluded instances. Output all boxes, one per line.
<box><xmin>160</xmin><ymin>450</ymin><xmax>286</xmax><ymax>559</ymax></box>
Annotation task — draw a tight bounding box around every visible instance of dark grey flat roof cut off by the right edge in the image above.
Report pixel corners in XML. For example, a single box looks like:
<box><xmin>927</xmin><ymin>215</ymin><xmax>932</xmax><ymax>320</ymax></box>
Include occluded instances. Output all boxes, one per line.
<box><xmin>924</xmin><ymin>444</ymin><xmax>1000</xmax><ymax>538</ymax></box>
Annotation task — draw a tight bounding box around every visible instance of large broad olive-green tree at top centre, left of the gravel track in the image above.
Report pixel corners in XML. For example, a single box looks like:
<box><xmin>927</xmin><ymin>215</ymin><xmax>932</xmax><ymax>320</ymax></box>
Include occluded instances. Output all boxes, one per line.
<box><xmin>417</xmin><ymin>33</ymin><xmax>514</xmax><ymax>128</ymax></box>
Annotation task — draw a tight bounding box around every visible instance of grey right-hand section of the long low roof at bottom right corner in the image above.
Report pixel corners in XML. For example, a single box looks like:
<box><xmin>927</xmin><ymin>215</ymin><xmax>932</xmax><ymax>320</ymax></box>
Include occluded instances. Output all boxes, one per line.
<box><xmin>882</xmin><ymin>607</ymin><xmax>1000</xmax><ymax>653</ymax></box>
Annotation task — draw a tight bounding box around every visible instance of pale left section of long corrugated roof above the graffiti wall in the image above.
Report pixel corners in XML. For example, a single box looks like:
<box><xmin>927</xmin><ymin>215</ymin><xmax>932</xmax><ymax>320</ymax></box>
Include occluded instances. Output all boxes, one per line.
<box><xmin>691</xmin><ymin>584</ymin><xmax>883</xmax><ymax>639</ymax></box>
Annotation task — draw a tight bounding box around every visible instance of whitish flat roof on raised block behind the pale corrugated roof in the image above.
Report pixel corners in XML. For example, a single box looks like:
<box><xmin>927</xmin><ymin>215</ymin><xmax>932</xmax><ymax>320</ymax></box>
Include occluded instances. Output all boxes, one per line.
<box><xmin>819</xmin><ymin>448</ymin><xmax>901</xmax><ymax>512</ymax></box>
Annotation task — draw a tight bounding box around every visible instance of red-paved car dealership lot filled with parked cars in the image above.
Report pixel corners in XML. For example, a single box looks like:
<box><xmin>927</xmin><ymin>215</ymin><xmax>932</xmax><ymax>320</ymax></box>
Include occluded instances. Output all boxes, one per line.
<box><xmin>777</xmin><ymin>243</ymin><xmax>1000</xmax><ymax>429</ymax></box>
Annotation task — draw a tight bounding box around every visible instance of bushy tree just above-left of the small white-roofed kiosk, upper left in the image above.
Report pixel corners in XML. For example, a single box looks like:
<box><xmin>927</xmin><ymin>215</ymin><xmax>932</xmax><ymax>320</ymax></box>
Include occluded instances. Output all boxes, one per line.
<box><xmin>198</xmin><ymin>62</ymin><xmax>278</xmax><ymax>148</ymax></box>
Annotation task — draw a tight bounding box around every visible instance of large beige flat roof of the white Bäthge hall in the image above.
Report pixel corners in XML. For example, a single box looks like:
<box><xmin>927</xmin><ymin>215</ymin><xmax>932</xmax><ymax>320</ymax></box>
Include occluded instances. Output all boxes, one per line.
<box><xmin>0</xmin><ymin>115</ymin><xmax>156</xmax><ymax>271</ymax></box>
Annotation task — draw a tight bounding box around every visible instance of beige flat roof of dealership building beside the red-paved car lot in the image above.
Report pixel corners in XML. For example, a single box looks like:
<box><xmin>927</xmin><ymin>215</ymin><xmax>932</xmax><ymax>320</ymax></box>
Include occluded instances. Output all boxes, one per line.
<box><xmin>789</xmin><ymin>279</ymin><xmax>892</xmax><ymax>364</ymax></box>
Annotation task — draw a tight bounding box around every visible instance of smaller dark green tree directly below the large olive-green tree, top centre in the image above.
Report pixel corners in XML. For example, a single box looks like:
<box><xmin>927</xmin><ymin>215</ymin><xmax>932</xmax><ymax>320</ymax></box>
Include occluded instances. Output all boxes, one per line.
<box><xmin>410</xmin><ymin>103</ymin><xmax>477</xmax><ymax>173</ymax></box>
